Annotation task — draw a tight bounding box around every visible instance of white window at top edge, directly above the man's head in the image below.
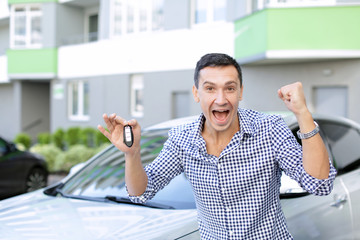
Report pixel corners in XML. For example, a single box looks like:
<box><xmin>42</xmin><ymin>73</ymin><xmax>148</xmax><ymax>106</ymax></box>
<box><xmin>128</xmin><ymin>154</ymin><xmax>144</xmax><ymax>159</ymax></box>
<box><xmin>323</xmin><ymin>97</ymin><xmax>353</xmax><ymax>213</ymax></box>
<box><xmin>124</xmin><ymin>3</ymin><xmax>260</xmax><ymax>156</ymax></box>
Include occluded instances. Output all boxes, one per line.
<box><xmin>195</xmin><ymin>0</ymin><xmax>226</xmax><ymax>24</ymax></box>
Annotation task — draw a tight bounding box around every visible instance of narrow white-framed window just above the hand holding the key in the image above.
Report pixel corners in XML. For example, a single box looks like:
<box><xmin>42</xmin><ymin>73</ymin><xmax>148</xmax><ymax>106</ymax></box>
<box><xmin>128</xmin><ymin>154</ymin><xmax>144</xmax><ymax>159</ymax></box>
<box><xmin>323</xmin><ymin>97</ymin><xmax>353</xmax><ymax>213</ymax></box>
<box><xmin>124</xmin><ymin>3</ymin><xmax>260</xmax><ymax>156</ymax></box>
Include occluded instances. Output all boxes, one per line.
<box><xmin>130</xmin><ymin>75</ymin><xmax>144</xmax><ymax>117</ymax></box>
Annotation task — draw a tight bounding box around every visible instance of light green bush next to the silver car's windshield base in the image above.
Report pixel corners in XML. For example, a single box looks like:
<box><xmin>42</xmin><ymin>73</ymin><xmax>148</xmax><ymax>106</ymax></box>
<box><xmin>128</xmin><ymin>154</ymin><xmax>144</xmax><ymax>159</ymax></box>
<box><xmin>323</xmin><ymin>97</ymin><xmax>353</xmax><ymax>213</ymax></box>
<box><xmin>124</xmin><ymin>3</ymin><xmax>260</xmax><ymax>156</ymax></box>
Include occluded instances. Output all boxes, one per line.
<box><xmin>56</xmin><ymin>144</ymin><xmax>95</xmax><ymax>172</ymax></box>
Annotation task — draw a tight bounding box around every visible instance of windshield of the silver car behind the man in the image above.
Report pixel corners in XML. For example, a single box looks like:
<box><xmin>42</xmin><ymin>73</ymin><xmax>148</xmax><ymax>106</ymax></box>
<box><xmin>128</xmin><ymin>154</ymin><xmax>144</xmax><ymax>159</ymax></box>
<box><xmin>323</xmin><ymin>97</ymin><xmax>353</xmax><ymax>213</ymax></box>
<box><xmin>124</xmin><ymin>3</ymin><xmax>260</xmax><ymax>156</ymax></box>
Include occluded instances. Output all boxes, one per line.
<box><xmin>61</xmin><ymin>130</ymin><xmax>195</xmax><ymax>209</ymax></box>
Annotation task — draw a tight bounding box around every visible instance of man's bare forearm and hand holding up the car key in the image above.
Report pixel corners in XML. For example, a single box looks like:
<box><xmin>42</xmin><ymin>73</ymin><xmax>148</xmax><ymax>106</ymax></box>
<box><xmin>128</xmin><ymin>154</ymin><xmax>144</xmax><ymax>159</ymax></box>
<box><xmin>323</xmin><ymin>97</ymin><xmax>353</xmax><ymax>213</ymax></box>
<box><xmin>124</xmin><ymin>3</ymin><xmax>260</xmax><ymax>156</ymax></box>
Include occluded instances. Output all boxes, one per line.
<box><xmin>98</xmin><ymin>114</ymin><xmax>148</xmax><ymax>196</ymax></box>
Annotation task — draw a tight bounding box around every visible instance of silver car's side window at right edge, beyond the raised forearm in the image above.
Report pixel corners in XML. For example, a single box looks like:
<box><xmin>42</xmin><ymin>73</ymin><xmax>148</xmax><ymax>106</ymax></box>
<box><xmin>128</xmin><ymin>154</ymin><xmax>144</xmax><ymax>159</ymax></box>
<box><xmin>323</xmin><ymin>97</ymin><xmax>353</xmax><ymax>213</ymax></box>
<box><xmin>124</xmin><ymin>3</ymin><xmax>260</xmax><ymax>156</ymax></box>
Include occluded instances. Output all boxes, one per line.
<box><xmin>319</xmin><ymin>122</ymin><xmax>360</xmax><ymax>174</ymax></box>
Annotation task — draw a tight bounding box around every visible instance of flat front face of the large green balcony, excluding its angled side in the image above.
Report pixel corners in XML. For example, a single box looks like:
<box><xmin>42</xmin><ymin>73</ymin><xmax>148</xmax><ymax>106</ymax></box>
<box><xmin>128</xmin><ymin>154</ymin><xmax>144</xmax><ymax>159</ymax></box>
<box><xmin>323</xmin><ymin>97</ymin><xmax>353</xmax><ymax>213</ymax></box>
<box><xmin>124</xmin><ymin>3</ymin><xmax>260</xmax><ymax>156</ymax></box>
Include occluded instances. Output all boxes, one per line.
<box><xmin>267</xmin><ymin>6</ymin><xmax>360</xmax><ymax>50</ymax></box>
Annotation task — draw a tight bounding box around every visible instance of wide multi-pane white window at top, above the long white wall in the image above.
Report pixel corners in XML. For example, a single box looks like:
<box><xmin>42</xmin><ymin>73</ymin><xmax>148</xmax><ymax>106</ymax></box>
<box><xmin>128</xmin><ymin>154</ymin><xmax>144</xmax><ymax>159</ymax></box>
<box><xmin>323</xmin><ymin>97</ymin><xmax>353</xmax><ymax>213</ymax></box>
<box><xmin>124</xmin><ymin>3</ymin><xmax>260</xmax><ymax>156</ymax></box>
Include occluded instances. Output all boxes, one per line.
<box><xmin>111</xmin><ymin>0</ymin><xmax>164</xmax><ymax>36</ymax></box>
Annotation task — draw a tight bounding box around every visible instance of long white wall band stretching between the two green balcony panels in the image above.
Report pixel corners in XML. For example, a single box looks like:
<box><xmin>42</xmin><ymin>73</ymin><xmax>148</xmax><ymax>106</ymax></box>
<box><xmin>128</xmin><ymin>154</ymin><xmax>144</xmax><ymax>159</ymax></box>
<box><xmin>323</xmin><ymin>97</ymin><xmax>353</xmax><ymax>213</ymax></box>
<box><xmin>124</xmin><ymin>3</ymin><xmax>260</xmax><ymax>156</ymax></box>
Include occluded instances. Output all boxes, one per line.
<box><xmin>58</xmin><ymin>23</ymin><xmax>234</xmax><ymax>78</ymax></box>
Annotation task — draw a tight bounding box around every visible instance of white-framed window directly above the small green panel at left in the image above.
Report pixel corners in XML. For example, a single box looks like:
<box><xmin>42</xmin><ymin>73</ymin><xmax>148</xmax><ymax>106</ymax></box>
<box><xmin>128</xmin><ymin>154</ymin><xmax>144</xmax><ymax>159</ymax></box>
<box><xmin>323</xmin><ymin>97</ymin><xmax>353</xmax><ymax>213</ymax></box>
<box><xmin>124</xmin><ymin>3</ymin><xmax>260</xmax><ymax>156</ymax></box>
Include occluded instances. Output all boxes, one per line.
<box><xmin>10</xmin><ymin>5</ymin><xmax>42</xmax><ymax>48</ymax></box>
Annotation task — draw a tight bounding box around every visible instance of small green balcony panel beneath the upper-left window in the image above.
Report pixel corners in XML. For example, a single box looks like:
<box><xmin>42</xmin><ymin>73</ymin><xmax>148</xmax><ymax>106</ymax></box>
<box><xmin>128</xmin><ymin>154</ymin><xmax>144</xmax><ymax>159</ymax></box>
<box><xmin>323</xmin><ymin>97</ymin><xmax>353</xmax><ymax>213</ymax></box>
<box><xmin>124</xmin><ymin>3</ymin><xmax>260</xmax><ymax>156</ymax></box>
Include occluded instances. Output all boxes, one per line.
<box><xmin>7</xmin><ymin>48</ymin><xmax>57</xmax><ymax>74</ymax></box>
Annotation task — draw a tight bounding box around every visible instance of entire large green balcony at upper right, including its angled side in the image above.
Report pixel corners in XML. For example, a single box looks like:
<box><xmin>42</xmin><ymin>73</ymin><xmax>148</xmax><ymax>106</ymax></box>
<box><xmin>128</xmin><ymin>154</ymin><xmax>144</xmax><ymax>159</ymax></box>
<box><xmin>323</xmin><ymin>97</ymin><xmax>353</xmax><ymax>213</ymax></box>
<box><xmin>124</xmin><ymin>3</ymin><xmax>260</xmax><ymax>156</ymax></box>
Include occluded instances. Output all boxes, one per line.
<box><xmin>235</xmin><ymin>6</ymin><xmax>360</xmax><ymax>59</ymax></box>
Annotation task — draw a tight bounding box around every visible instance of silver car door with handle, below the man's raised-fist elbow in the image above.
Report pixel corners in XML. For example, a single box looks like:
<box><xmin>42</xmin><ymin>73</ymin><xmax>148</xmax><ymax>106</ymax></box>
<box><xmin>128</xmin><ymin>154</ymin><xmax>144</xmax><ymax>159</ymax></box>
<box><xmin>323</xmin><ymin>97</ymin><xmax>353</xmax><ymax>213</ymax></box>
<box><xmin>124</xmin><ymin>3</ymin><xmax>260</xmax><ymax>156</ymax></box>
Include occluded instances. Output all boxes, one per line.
<box><xmin>281</xmin><ymin>122</ymin><xmax>352</xmax><ymax>240</ymax></box>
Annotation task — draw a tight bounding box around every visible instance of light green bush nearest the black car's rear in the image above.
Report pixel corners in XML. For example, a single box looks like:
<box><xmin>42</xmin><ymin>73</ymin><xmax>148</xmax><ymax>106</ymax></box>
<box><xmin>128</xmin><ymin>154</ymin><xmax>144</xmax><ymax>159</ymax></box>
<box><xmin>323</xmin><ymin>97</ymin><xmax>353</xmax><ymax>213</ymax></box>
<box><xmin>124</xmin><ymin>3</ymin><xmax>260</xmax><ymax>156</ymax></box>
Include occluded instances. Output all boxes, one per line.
<box><xmin>30</xmin><ymin>144</ymin><xmax>62</xmax><ymax>172</ymax></box>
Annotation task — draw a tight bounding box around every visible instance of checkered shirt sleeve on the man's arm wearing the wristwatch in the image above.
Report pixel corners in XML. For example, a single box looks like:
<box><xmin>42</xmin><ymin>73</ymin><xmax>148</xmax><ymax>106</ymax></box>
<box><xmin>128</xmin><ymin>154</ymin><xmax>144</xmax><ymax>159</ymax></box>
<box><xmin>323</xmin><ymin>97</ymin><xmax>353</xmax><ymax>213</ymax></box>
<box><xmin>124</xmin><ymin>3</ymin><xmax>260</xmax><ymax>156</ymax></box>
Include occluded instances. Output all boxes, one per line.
<box><xmin>273</xmin><ymin>116</ymin><xmax>336</xmax><ymax>196</ymax></box>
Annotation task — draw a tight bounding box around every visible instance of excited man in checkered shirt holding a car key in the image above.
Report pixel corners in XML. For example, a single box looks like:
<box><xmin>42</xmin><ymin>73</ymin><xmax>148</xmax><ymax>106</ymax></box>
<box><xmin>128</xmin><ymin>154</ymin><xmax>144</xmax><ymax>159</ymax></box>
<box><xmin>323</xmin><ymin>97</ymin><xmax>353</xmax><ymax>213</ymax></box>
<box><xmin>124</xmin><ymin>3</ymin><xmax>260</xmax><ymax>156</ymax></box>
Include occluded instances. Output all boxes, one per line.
<box><xmin>99</xmin><ymin>54</ymin><xmax>336</xmax><ymax>239</ymax></box>
